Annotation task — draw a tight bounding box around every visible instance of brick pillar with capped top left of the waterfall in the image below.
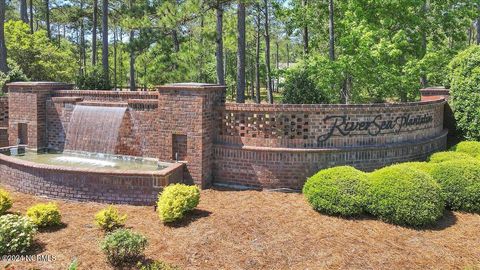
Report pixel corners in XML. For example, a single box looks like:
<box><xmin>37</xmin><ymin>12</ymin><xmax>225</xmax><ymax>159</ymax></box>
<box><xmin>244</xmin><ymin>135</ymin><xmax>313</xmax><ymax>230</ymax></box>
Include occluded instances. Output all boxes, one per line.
<box><xmin>7</xmin><ymin>82</ymin><xmax>73</xmax><ymax>150</ymax></box>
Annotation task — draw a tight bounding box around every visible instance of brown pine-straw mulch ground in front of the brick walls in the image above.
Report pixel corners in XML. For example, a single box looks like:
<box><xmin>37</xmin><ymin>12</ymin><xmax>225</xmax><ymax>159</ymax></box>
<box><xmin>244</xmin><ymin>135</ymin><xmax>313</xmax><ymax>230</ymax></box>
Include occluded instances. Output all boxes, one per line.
<box><xmin>0</xmin><ymin>186</ymin><xmax>480</xmax><ymax>269</ymax></box>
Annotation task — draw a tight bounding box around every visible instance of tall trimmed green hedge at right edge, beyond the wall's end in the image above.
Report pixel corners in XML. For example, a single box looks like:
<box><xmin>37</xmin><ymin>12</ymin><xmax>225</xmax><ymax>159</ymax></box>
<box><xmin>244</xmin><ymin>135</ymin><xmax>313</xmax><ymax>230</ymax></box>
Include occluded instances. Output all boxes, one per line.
<box><xmin>449</xmin><ymin>46</ymin><xmax>480</xmax><ymax>140</ymax></box>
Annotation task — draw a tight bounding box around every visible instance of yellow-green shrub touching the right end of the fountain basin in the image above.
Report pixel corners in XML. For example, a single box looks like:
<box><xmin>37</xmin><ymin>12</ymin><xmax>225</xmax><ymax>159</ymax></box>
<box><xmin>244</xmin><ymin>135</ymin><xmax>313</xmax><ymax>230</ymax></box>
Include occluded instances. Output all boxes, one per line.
<box><xmin>157</xmin><ymin>184</ymin><xmax>200</xmax><ymax>222</ymax></box>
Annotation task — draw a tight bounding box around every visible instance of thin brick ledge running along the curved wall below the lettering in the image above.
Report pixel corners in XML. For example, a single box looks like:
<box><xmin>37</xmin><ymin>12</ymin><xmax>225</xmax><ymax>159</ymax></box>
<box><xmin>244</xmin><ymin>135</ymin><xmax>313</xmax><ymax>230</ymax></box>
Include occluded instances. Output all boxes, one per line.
<box><xmin>214</xmin><ymin>129</ymin><xmax>448</xmax><ymax>153</ymax></box>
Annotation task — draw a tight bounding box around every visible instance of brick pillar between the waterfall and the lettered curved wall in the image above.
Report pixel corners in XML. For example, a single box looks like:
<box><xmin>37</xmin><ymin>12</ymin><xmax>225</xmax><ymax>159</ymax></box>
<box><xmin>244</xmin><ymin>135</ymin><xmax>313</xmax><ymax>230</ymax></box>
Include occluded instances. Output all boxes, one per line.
<box><xmin>157</xmin><ymin>83</ymin><xmax>225</xmax><ymax>188</ymax></box>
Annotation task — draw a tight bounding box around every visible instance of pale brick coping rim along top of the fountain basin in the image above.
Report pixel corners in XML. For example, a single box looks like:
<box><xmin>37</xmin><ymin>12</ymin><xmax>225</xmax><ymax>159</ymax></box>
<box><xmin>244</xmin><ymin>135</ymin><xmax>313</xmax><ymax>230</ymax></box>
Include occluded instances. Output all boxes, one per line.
<box><xmin>0</xmin><ymin>154</ymin><xmax>184</xmax><ymax>176</ymax></box>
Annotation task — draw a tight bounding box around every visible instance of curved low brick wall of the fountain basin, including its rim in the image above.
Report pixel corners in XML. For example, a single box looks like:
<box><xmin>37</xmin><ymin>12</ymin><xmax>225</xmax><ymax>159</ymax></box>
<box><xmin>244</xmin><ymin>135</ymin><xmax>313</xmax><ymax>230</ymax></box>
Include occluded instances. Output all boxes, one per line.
<box><xmin>0</xmin><ymin>154</ymin><xmax>184</xmax><ymax>205</ymax></box>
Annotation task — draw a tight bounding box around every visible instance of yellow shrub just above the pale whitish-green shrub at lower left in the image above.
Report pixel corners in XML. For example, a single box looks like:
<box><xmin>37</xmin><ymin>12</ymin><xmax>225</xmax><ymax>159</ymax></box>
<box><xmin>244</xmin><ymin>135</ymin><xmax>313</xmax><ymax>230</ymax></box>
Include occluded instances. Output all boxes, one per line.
<box><xmin>27</xmin><ymin>203</ymin><xmax>62</xmax><ymax>227</ymax></box>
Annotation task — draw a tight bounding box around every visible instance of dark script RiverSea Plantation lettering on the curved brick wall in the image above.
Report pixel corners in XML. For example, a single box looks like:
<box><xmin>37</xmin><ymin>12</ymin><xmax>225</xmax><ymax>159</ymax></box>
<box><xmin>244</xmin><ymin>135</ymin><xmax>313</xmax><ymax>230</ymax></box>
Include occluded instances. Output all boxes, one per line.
<box><xmin>317</xmin><ymin>114</ymin><xmax>433</xmax><ymax>144</ymax></box>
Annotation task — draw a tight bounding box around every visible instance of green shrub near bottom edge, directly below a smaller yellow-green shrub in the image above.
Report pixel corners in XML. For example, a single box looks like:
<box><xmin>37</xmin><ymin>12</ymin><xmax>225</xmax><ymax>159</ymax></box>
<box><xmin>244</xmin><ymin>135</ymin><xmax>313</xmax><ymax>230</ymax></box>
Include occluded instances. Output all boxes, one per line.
<box><xmin>101</xmin><ymin>229</ymin><xmax>147</xmax><ymax>265</ymax></box>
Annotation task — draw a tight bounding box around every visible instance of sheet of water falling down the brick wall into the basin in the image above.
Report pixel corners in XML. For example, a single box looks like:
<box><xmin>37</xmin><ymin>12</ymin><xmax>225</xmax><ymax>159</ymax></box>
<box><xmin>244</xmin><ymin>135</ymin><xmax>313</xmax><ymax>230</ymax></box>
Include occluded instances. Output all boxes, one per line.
<box><xmin>65</xmin><ymin>105</ymin><xmax>127</xmax><ymax>154</ymax></box>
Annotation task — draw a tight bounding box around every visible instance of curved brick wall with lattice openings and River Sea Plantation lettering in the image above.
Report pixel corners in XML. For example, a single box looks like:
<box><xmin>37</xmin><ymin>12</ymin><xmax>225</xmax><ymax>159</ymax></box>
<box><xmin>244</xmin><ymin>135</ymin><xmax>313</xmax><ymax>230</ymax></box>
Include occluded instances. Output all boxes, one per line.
<box><xmin>213</xmin><ymin>98</ymin><xmax>447</xmax><ymax>189</ymax></box>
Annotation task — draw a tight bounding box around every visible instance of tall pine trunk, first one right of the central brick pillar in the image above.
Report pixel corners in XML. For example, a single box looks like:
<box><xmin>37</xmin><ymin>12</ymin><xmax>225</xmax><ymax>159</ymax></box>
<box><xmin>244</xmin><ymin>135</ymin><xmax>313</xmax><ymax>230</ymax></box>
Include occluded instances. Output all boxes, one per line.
<box><xmin>237</xmin><ymin>0</ymin><xmax>246</xmax><ymax>103</ymax></box>
